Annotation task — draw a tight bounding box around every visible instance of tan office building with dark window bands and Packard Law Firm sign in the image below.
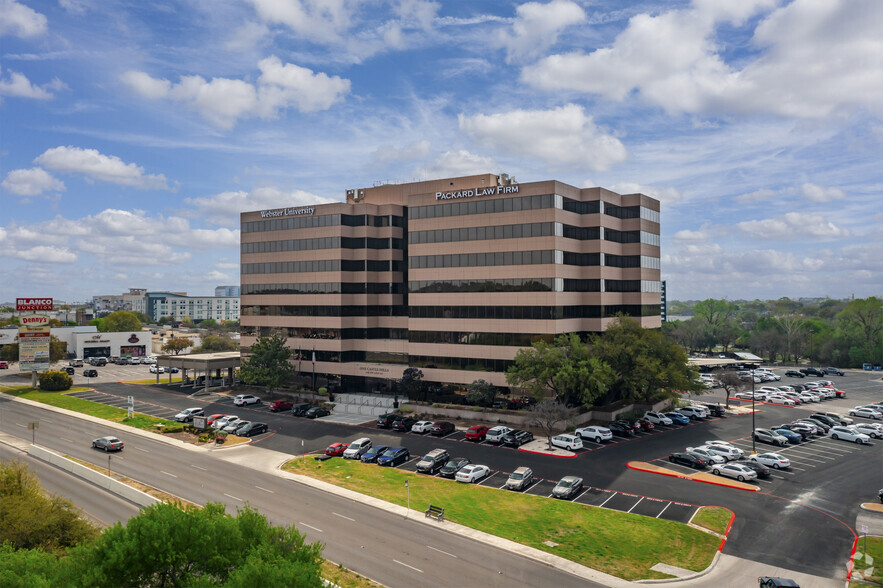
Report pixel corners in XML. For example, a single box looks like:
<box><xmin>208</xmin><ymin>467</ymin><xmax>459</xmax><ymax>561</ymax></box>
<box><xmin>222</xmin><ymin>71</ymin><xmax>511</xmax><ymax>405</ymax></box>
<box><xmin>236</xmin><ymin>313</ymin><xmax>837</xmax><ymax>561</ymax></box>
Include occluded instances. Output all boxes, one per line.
<box><xmin>240</xmin><ymin>174</ymin><xmax>661</xmax><ymax>390</ymax></box>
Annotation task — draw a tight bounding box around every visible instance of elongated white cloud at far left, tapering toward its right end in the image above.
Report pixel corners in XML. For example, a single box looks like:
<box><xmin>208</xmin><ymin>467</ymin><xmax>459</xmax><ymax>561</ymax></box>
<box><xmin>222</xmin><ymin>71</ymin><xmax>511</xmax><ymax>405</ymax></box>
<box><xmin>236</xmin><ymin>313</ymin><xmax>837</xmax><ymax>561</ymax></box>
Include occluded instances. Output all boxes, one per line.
<box><xmin>34</xmin><ymin>146</ymin><xmax>169</xmax><ymax>190</ymax></box>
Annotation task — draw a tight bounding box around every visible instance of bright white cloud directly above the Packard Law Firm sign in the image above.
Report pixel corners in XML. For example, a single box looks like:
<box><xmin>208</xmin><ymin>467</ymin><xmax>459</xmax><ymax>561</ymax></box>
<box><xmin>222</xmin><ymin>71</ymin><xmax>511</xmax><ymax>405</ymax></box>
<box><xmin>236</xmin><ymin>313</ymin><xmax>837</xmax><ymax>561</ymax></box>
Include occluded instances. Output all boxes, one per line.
<box><xmin>458</xmin><ymin>104</ymin><xmax>626</xmax><ymax>171</ymax></box>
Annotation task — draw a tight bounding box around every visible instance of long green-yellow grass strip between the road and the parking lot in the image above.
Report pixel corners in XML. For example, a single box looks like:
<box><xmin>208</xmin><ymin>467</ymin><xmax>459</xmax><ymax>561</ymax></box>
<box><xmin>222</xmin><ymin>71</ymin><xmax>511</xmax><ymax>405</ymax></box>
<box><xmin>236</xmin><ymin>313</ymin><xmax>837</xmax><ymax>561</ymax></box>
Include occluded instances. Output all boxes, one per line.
<box><xmin>284</xmin><ymin>457</ymin><xmax>731</xmax><ymax>580</ymax></box>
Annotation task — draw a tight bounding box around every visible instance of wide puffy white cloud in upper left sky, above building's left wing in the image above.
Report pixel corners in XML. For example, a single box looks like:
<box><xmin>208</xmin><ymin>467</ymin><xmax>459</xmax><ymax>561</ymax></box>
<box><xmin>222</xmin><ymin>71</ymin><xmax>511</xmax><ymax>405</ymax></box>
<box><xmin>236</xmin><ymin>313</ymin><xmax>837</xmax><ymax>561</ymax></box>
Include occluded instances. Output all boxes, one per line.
<box><xmin>120</xmin><ymin>56</ymin><xmax>350</xmax><ymax>129</ymax></box>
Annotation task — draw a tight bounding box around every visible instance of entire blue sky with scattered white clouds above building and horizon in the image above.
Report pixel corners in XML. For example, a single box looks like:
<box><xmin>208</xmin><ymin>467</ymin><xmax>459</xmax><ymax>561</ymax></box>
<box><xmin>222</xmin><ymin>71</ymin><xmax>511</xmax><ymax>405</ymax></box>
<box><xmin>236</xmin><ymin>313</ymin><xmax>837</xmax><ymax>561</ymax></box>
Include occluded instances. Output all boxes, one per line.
<box><xmin>0</xmin><ymin>0</ymin><xmax>883</xmax><ymax>301</ymax></box>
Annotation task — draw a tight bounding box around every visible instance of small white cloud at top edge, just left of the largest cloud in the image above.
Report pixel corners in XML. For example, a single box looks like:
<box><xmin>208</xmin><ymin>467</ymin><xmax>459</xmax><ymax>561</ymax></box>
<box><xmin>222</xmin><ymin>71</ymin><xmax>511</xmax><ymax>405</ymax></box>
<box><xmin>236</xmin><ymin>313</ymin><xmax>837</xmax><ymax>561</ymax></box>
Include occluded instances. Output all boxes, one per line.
<box><xmin>497</xmin><ymin>0</ymin><xmax>586</xmax><ymax>61</ymax></box>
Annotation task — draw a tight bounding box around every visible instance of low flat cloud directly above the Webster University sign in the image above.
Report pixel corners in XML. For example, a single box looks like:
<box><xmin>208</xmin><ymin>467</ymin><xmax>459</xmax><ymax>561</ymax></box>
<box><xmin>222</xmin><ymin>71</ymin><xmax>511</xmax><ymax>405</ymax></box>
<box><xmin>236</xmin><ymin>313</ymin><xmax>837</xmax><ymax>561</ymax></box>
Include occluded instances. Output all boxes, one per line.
<box><xmin>182</xmin><ymin>186</ymin><xmax>334</xmax><ymax>227</ymax></box>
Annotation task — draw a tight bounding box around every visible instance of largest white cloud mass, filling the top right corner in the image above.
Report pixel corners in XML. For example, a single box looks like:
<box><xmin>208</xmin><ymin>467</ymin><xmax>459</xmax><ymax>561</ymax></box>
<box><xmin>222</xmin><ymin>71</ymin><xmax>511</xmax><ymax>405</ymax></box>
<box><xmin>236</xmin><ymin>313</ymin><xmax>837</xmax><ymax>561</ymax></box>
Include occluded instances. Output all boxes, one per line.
<box><xmin>522</xmin><ymin>0</ymin><xmax>883</xmax><ymax>117</ymax></box>
